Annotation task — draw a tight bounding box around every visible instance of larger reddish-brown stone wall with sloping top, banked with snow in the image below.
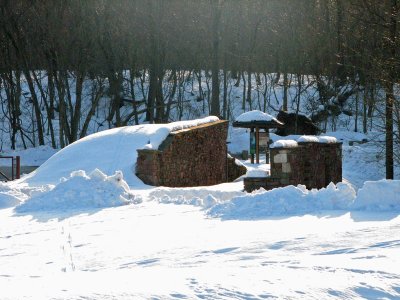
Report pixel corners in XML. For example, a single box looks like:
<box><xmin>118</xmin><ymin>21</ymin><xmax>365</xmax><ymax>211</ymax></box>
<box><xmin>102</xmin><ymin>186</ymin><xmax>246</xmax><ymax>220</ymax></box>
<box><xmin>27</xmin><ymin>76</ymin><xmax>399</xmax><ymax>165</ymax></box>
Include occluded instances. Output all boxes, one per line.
<box><xmin>136</xmin><ymin>121</ymin><xmax>243</xmax><ymax>187</ymax></box>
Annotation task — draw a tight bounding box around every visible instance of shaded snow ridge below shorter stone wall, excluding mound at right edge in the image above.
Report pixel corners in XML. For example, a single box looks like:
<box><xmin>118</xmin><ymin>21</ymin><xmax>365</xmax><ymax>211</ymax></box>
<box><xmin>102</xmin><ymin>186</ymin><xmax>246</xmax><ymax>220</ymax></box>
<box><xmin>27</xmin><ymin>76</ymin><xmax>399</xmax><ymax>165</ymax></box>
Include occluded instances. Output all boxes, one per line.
<box><xmin>208</xmin><ymin>183</ymin><xmax>356</xmax><ymax>219</ymax></box>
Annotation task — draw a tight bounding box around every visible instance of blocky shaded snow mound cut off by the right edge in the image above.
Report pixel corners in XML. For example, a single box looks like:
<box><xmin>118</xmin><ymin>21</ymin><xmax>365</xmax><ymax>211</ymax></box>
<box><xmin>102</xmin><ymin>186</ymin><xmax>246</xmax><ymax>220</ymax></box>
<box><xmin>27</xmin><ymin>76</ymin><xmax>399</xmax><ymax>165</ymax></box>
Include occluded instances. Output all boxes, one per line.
<box><xmin>354</xmin><ymin>179</ymin><xmax>400</xmax><ymax>212</ymax></box>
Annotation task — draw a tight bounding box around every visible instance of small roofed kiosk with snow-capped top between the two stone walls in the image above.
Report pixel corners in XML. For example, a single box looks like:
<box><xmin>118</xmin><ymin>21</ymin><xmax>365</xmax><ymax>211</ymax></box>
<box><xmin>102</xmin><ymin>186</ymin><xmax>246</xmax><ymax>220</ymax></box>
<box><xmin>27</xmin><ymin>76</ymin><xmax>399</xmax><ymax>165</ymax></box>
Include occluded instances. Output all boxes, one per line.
<box><xmin>232</xmin><ymin>110</ymin><xmax>284</xmax><ymax>164</ymax></box>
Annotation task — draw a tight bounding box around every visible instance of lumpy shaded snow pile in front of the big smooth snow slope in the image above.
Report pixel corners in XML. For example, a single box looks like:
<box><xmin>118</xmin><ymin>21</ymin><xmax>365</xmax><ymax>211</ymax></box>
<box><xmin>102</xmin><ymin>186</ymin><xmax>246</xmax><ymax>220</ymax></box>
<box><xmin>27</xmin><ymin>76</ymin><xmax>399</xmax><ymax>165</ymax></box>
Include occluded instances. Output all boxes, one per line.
<box><xmin>15</xmin><ymin>169</ymin><xmax>140</xmax><ymax>213</ymax></box>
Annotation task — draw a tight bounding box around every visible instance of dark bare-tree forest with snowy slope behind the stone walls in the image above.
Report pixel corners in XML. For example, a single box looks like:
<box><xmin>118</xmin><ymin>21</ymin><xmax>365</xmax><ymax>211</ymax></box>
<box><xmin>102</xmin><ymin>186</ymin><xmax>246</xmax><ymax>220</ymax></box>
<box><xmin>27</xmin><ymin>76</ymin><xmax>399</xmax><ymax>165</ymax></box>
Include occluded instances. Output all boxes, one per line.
<box><xmin>0</xmin><ymin>0</ymin><xmax>400</xmax><ymax>178</ymax></box>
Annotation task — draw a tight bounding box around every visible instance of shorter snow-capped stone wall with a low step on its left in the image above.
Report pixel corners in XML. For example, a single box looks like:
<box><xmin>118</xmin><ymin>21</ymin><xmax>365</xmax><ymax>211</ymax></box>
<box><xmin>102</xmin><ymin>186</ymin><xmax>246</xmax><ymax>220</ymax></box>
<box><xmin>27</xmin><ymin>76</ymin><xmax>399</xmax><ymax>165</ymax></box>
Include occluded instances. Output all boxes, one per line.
<box><xmin>244</xmin><ymin>137</ymin><xmax>342</xmax><ymax>192</ymax></box>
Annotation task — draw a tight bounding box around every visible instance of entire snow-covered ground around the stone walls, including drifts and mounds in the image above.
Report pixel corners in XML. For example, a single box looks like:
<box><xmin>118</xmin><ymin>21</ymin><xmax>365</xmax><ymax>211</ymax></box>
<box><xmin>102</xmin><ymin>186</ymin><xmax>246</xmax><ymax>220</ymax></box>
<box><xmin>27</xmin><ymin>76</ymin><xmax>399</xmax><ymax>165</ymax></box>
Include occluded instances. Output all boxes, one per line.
<box><xmin>0</xmin><ymin>118</ymin><xmax>400</xmax><ymax>299</ymax></box>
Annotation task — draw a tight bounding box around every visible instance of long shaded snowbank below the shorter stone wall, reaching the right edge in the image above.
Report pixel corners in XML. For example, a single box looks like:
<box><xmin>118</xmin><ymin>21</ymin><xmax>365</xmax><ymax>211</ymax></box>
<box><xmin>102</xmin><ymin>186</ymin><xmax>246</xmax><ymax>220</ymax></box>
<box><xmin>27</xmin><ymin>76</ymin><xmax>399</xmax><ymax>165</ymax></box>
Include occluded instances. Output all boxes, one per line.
<box><xmin>208</xmin><ymin>180</ymin><xmax>400</xmax><ymax>219</ymax></box>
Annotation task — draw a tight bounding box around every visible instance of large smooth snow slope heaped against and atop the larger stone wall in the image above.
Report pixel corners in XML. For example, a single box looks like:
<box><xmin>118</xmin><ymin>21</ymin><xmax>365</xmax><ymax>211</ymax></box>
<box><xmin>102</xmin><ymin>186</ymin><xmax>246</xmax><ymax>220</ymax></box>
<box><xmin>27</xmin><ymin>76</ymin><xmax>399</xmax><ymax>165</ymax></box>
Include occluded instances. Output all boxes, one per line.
<box><xmin>21</xmin><ymin>117</ymin><xmax>219</xmax><ymax>188</ymax></box>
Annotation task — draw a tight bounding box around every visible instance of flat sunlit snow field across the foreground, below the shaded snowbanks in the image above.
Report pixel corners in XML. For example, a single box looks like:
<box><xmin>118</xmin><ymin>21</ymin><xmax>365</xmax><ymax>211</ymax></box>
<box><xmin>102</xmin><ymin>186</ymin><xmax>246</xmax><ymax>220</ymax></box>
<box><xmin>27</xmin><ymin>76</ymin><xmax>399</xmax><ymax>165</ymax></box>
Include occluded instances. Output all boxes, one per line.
<box><xmin>0</xmin><ymin>201</ymin><xmax>400</xmax><ymax>299</ymax></box>
